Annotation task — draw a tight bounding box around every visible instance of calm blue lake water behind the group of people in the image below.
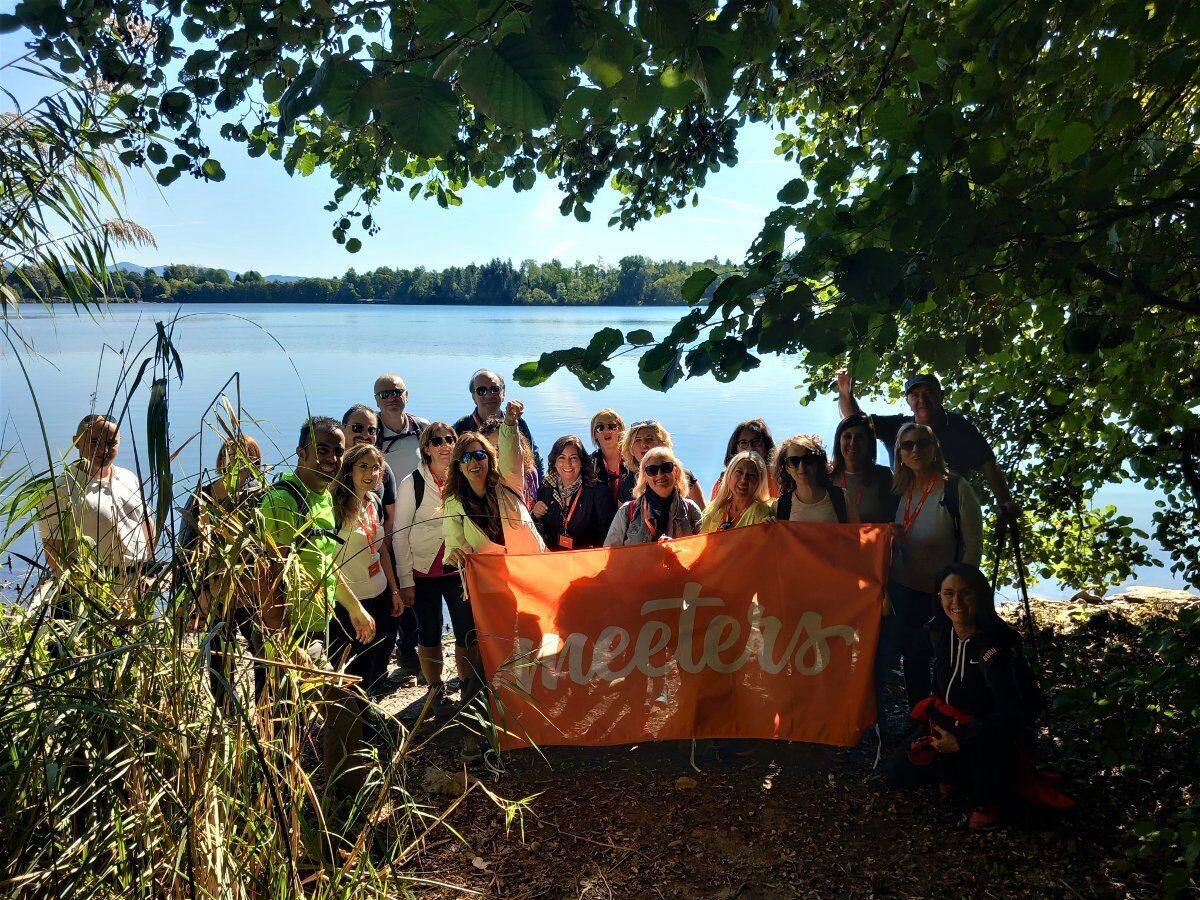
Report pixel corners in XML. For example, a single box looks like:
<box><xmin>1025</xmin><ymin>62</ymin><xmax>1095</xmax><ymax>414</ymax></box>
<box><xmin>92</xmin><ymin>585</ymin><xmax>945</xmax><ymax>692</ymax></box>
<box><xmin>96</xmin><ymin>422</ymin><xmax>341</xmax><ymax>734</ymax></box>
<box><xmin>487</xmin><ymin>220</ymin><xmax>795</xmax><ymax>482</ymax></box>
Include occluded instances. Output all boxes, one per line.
<box><xmin>0</xmin><ymin>304</ymin><xmax>1183</xmax><ymax>595</ymax></box>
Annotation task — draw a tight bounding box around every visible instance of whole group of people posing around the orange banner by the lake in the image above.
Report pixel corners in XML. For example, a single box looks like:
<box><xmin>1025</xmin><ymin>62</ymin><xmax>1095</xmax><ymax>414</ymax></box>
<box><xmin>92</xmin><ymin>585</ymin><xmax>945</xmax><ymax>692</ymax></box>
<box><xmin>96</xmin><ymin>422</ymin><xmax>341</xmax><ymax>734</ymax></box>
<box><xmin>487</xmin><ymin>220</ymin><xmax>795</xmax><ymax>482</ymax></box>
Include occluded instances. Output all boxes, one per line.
<box><xmin>41</xmin><ymin>370</ymin><xmax>1051</xmax><ymax>827</ymax></box>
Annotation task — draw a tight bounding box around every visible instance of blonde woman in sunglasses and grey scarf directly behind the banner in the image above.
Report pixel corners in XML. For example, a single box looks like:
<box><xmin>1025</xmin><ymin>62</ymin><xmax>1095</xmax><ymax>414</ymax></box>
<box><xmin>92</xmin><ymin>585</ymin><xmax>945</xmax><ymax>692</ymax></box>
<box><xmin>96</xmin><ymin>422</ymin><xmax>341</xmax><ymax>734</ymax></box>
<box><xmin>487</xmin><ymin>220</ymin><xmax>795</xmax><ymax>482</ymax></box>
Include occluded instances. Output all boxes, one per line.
<box><xmin>604</xmin><ymin>446</ymin><xmax>702</xmax><ymax>547</ymax></box>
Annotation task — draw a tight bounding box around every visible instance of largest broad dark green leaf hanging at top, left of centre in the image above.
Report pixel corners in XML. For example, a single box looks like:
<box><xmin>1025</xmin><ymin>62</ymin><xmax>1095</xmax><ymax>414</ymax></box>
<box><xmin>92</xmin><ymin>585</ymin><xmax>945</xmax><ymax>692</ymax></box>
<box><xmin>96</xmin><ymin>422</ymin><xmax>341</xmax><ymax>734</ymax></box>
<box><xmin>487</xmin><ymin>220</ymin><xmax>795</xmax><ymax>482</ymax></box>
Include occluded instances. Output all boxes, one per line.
<box><xmin>461</xmin><ymin>34</ymin><xmax>566</xmax><ymax>131</ymax></box>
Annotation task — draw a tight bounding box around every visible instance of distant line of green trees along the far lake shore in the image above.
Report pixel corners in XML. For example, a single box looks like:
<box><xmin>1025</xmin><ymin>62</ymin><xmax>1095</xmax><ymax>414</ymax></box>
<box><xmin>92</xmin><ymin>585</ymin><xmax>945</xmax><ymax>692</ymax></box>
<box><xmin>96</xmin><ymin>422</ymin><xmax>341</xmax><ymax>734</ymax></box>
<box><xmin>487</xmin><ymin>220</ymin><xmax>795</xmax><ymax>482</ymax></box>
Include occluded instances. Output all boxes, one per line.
<box><xmin>14</xmin><ymin>256</ymin><xmax>732</xmax><ymax>306</ymax></box>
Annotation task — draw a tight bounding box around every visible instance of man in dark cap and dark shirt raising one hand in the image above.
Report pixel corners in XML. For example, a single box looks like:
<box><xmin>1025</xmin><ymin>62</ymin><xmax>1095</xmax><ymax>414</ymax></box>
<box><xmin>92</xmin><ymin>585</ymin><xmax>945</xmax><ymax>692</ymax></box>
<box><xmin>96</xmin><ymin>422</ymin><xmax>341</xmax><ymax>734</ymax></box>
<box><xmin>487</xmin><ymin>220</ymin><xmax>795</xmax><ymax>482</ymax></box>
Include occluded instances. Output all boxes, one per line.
<box><xmin>838</xmin><ymin>370</ymin><xmax>1019</xmax><ymax>516</ymax></box>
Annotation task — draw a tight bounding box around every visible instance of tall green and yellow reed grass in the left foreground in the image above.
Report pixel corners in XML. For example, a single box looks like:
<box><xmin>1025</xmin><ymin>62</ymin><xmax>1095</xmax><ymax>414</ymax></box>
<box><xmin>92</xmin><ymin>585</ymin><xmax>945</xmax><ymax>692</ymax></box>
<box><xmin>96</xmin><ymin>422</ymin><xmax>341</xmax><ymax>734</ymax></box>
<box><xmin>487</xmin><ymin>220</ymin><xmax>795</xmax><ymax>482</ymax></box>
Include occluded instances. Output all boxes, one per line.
<box><xmin>0</xmin><ymin>323</ymin><xmax>521</xmax><ymax>898</ymax></box>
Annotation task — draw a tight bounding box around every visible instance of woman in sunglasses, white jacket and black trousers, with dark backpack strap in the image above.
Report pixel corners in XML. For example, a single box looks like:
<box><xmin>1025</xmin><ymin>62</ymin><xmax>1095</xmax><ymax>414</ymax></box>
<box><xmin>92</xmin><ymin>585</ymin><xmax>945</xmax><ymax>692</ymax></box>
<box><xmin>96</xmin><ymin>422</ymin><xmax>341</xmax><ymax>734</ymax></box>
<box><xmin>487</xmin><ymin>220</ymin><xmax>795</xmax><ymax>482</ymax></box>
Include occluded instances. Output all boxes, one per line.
<box><xmin>391</xmin><ymin>422</ymin><xmax>475</xmax><ymax>715</ymax></box>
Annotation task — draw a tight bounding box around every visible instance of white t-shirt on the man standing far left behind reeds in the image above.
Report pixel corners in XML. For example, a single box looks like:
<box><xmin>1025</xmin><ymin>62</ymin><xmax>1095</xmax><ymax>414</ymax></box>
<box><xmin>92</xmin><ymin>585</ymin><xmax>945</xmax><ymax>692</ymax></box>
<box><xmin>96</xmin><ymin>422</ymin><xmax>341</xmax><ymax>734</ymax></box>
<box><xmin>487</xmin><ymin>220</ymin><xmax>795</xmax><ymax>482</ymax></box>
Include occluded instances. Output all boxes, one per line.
<box><xmin>38</xmin><ymin>461</ymin><xmax>149</xmax><ymax>566</ymax></box>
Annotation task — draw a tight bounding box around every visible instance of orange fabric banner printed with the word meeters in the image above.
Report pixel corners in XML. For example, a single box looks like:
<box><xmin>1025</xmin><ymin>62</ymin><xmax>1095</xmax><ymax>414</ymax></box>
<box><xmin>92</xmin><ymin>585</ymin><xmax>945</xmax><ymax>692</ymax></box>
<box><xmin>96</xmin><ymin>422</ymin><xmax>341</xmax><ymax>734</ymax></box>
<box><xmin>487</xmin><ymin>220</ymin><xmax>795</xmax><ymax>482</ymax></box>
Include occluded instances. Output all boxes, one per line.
<box><xmin>467</xmin><ymin>522</ymin><xmax>892</xmax><ymax>748</ymax></box>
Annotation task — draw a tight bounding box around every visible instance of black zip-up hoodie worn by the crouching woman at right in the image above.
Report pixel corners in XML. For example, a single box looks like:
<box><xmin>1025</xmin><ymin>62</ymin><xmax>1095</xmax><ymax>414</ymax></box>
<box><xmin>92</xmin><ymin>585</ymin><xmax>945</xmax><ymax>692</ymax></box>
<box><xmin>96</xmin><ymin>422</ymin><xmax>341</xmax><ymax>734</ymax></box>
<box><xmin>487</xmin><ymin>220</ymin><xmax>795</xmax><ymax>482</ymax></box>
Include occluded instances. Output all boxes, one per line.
<box><xmin>925</xmin><ymin>616</ymin><xmax>1039</xmax><ymax>749</ymax></box>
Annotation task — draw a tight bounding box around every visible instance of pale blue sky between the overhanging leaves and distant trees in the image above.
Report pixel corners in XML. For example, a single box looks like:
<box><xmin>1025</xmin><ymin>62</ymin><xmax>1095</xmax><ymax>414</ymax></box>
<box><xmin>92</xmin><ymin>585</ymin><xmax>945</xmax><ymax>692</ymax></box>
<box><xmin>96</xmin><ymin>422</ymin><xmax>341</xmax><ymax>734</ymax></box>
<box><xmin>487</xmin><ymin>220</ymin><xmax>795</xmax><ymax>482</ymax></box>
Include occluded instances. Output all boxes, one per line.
<box><xmin>0</xmin><ymin>24</ymin><xmax>797</xmax><ymax>276</ymax></box>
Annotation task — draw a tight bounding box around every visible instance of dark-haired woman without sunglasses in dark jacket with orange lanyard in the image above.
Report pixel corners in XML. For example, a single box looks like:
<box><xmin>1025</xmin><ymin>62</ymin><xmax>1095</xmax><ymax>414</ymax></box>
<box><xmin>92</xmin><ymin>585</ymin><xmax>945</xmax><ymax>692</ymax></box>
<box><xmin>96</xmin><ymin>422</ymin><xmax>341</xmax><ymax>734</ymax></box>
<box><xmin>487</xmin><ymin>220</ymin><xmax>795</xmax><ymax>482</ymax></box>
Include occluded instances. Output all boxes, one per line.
<box><xmin>533</xmin><ymin>434</ymin><xmax>617</xmax><ymax>550</ymax></box>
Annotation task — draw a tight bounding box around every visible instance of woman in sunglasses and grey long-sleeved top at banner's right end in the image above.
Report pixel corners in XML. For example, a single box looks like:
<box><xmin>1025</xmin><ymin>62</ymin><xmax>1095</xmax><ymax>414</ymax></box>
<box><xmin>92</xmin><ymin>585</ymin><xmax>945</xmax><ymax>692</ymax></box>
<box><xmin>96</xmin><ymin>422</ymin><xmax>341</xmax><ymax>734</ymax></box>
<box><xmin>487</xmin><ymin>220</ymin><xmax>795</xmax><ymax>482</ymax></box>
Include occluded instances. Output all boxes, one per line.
<box><xmin>878</xmin><ymin>422</ymin><xmax>983</xmax><ymax>709</ymax></box>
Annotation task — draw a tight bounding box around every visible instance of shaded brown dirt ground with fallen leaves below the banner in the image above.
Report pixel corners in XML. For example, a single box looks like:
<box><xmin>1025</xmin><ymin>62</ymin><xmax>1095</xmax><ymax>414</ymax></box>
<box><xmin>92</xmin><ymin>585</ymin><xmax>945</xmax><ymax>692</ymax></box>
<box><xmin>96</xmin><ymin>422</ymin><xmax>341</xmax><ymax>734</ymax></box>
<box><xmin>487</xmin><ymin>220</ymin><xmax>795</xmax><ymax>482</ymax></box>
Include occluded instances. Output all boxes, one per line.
<box><xmin>372</xmin><ymin>688</ymin><xmax>1142</xmax><ymax>899</ymax></box>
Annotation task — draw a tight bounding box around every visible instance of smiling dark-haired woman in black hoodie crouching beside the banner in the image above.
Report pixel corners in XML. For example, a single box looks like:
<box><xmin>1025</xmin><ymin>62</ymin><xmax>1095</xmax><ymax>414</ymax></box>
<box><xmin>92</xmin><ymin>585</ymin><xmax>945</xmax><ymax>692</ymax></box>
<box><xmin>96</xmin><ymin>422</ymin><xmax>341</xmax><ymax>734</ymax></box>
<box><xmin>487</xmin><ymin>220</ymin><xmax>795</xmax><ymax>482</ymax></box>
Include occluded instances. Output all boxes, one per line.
<box><xmin>886</xmin><ymin>563</ymin><xmax>1042</xmax><ymax>830</ymax></box>
